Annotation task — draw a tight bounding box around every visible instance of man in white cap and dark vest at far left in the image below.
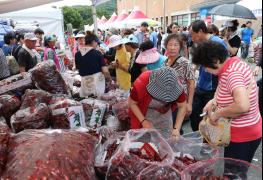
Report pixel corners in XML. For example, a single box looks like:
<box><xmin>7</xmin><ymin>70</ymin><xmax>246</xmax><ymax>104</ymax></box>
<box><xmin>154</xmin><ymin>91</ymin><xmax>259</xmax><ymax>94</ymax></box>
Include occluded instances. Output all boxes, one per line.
<box><xmin>18</xmin><ymin>33</ymin><xmax>38</xmax><ymax>72</ymax></box>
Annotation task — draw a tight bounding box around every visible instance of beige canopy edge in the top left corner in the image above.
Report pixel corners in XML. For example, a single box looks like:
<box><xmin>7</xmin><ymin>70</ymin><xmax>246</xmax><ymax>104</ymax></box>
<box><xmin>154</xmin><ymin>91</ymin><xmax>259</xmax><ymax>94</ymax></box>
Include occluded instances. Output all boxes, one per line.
<box><xmin>0</xmin><ymin>0</ymin><xmax>61</xmax><ymax>14</ymax></box>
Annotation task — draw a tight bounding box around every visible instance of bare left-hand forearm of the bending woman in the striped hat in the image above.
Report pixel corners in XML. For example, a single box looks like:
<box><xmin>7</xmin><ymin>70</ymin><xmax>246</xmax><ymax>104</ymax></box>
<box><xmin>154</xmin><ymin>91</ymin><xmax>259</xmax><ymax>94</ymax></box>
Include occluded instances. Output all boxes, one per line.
<box><xmin>128</xmin><ymin>97</ymin><xmax>153</xmax><ymax>129</ymax></box>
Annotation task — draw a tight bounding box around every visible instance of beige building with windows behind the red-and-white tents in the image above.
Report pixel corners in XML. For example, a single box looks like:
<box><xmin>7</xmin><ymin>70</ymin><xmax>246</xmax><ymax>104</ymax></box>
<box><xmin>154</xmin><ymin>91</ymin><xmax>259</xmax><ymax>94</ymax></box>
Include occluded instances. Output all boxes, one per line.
<box><xmin>117</xmin><ymin>0</ymin><xmax>262</xmax><ymax>32</ymax></box>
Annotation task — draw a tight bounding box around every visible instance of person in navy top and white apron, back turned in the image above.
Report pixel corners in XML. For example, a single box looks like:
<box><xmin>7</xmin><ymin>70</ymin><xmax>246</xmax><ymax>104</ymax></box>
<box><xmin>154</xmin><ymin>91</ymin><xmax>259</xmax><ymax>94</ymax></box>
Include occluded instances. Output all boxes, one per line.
<box><xmin>75</xmin><ymin>34</ymin><xmax>111</xmax><ymax>97</ymax></box>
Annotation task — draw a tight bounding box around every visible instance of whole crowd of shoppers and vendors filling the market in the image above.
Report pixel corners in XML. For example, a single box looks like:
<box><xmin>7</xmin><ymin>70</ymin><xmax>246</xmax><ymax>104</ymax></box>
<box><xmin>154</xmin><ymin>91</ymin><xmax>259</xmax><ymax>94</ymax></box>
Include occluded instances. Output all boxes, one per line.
<box><xmin>0</xmin><ymin>20</ymin><xmax>262</xmax><ymax>174</ymax></box>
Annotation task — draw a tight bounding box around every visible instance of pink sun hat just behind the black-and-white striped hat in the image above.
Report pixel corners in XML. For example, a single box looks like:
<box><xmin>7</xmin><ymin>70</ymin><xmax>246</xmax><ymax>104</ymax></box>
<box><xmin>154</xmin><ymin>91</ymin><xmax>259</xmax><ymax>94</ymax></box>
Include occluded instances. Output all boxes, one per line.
<box><xmin>136</xmin><ymin>48</ymin><xmax>161</xmax><ymax>64</ymax></box>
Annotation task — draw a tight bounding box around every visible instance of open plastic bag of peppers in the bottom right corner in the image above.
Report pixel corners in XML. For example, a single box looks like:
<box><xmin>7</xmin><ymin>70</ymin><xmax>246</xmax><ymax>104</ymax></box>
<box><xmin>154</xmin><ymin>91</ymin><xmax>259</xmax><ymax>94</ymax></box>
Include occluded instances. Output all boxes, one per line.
<box><xmin>181</xmin><ymin>158</ymin><xmax>262</xmax><ymax>180</ymax></box>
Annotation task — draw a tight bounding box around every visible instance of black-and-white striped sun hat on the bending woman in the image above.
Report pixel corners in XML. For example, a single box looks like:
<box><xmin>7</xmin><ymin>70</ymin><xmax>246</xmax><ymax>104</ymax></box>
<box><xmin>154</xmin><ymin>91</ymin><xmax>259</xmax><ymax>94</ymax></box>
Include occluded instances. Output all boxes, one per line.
<box><xmin>146</xmin><ymin>67</ymin><xmax>183</xmax><ymax>103</ymax></box>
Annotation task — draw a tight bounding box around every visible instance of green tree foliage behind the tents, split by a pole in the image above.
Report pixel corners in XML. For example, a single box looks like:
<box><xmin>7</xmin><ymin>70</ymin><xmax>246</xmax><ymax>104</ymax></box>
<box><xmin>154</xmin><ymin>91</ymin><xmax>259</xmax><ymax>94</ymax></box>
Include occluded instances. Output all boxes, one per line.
<box><xmin>62</xmin><ymin>0</ymin><xmax>117</xmax><ymax>29</ymax></box>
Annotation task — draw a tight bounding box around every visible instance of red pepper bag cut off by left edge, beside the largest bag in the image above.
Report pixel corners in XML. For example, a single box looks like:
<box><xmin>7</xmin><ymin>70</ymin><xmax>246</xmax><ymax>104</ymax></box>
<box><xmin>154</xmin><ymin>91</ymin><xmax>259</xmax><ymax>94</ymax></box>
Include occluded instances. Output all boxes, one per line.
<box><xmin>0</xmin><ymin>117</ymin><xmax>10</xmax><ymax>176</ymax></box>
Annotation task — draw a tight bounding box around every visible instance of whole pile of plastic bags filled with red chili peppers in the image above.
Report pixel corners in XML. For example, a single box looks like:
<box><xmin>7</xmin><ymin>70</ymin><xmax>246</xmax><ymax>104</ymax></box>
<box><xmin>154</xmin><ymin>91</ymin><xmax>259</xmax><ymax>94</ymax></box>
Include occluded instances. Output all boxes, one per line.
<box><xmin>0</xmin><ymin>61</ymin><xmax>262</xmax><ymax>180</ymax></box>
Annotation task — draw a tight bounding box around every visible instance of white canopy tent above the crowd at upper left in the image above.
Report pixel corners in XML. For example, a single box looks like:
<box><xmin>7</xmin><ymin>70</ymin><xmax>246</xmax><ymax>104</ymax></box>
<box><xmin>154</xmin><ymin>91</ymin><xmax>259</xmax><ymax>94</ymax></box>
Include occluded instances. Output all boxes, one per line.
<box><xmin>0</xmin><ymin>7</ymin><xmax>65</xmax><ymax>44</ymax></box>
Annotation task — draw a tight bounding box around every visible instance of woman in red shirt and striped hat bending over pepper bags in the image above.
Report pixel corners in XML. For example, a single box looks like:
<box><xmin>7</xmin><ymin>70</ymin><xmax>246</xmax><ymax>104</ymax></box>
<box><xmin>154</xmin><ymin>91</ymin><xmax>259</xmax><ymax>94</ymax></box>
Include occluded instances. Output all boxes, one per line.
<box><xmin>128</xmin><ymin>67</ymin><xmax>186</xmax><ymax>138</ymax></box>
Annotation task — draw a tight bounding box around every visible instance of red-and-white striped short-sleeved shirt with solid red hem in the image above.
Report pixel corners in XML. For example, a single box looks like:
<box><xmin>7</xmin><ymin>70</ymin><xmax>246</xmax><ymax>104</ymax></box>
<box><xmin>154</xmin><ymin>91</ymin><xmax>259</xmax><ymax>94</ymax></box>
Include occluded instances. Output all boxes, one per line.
<box><xmin>216</xmin><ymin>57</ymin><xmax>262</xmax><ymax>142</ymax></box>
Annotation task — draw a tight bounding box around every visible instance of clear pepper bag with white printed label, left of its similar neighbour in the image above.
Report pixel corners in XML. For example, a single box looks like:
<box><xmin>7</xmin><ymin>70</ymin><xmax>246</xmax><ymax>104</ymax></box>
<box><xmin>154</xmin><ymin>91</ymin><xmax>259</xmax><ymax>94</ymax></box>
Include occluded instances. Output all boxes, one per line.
<box><xmin>49</xmin><ymin>97</ymin><xmax>86</xmax><ymax>129</ymax></box>
